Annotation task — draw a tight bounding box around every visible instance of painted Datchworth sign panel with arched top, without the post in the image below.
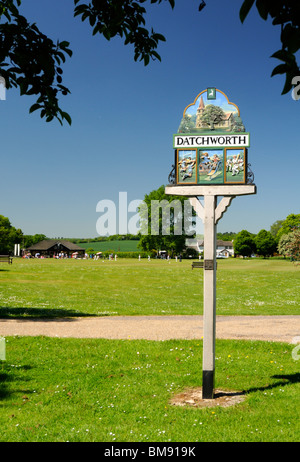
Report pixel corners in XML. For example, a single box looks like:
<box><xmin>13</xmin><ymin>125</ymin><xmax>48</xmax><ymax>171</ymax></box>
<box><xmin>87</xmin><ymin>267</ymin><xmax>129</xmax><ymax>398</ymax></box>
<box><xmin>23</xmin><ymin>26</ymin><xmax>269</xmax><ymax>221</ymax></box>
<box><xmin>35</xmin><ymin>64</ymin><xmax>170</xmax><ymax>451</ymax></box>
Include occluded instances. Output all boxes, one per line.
<box><xmin>173</xmin><ymin>87</ymin><xmax>250</xmax><ymax>185</ymax></box>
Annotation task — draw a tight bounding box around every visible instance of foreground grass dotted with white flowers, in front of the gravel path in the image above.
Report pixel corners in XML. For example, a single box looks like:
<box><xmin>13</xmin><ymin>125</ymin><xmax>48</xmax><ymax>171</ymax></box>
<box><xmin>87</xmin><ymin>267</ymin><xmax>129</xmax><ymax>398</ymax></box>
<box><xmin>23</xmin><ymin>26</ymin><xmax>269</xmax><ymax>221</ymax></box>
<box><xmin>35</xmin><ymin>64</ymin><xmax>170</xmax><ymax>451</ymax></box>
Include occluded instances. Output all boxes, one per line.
<box><xmin>0</xmin><ymin>337</ymin><xmax>300</xmax><ymax>442</ymax></box>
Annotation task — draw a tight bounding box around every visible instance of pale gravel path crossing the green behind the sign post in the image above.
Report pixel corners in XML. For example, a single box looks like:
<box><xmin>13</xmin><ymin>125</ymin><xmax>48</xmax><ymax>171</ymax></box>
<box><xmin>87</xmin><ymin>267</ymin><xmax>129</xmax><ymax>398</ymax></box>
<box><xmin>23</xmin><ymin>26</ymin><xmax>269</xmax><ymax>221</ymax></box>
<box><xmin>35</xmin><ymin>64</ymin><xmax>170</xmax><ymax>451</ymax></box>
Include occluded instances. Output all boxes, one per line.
<box><xmin>0</xmin><ymin>316</ymin><xmax>300</xmax><ymax>343</ymax></box>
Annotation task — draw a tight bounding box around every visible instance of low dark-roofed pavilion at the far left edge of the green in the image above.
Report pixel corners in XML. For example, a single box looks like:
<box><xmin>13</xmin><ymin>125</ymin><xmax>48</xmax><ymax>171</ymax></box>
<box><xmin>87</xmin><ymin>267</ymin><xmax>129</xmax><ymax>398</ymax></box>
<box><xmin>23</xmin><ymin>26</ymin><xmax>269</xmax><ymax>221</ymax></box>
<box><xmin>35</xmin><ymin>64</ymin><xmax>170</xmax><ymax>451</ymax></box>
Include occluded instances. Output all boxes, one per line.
<box><xmin>27</xmin><ymin>239</ymin><xmax>85</xmax><ymax>258</ymax></box>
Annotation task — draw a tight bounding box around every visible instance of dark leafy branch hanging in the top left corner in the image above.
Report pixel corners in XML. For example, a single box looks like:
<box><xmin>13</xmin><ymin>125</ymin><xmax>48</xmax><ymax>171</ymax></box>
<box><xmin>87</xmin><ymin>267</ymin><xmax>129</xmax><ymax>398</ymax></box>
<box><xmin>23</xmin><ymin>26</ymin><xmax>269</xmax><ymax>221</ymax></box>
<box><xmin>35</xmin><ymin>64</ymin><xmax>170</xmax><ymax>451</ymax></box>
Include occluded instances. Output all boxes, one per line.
<box><xmin>0</xmin><ymin>0</ymin><xmax>72</xmax><ymax>124</ymax></box>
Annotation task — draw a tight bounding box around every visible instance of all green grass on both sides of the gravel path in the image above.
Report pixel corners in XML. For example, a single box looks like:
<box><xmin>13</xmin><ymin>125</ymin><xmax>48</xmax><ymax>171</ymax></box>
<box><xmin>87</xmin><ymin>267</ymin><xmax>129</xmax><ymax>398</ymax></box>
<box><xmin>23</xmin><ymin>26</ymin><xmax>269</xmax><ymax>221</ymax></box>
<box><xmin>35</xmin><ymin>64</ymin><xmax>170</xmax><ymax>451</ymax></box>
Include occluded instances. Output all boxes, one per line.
<box><xmin>0</xmin><ymin>259</ymin><xmax>300</xmax><ymax>442</ymax></box>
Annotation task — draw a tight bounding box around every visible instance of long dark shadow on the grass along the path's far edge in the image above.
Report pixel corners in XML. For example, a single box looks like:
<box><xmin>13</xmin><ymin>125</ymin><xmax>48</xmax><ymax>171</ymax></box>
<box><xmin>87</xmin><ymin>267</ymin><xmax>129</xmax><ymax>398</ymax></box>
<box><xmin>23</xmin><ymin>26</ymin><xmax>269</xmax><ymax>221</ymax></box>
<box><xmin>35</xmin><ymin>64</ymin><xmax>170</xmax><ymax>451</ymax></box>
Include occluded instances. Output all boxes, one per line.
<box><xmin>0</xmin><ymin>306</ymin><xmax>95</xmax><ymax>321</ymax></box>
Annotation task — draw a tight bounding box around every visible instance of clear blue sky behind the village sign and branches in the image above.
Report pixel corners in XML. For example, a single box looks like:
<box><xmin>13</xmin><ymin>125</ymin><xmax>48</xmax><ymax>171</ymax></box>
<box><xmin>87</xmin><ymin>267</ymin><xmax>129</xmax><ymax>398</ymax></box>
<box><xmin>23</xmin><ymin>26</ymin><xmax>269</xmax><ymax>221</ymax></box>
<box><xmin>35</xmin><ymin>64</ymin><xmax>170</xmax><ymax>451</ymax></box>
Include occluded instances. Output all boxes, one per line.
<box><xmin>0</xmin><ymin>0</ymin><xmax>300</xmax><ymax>237</ymax></box>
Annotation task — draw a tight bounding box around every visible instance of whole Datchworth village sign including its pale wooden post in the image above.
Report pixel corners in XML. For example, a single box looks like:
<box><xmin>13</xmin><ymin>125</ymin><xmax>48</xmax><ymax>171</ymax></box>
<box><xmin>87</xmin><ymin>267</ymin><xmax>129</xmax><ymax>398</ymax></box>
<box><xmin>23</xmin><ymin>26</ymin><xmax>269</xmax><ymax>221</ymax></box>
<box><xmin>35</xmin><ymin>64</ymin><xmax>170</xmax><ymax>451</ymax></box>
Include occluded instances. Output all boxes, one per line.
<box><xmin>165</xmin><ymin>88</ymin><xmax>256</xmax><ymax>399</ymax></box>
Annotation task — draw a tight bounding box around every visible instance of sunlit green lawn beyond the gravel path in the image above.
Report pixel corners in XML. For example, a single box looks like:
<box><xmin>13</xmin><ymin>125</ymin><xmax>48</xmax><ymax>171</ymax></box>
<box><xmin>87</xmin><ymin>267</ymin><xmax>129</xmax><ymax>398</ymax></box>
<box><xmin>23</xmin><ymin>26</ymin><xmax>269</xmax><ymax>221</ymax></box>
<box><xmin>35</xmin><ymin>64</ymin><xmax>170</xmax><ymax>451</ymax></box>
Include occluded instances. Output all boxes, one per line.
<box><xmin>0</xmin><ymin>259</ymin><xmax>300</xmax><ymax>317</ymax></box>
